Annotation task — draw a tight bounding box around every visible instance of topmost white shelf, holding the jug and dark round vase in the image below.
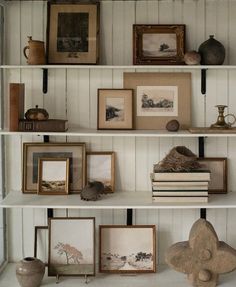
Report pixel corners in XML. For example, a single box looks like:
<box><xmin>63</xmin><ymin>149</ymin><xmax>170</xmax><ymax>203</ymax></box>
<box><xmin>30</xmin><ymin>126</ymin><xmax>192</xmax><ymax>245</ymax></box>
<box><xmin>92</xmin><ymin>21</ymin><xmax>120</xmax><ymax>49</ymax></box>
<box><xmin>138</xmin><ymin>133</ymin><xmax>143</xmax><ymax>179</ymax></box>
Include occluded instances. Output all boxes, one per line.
<box><xmin>0</xmin><ymin>65</ymin><xmax>236</xmax><ymax>70</ymax></box>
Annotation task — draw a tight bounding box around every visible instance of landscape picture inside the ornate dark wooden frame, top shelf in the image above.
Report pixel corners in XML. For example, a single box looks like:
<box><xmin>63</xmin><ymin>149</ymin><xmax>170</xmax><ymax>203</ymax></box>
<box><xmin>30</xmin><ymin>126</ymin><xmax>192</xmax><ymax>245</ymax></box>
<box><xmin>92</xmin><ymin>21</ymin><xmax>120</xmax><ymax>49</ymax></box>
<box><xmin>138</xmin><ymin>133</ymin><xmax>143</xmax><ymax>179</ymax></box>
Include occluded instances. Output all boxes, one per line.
<box><xmin>143</xmin><ymin>33</ymin><xmax>177</xmax><ymax>57</ymax></box>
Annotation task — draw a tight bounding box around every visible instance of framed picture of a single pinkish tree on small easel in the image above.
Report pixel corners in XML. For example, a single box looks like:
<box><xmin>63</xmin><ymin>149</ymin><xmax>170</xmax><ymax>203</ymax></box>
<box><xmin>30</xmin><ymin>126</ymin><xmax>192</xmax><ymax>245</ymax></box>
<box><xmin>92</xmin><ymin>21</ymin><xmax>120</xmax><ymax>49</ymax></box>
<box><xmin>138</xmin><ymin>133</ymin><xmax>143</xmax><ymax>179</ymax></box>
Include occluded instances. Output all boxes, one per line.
<box><xmin>48</xmin><ymin>217</ymin><xmax>95</xmax><ymax>276</ymax></box>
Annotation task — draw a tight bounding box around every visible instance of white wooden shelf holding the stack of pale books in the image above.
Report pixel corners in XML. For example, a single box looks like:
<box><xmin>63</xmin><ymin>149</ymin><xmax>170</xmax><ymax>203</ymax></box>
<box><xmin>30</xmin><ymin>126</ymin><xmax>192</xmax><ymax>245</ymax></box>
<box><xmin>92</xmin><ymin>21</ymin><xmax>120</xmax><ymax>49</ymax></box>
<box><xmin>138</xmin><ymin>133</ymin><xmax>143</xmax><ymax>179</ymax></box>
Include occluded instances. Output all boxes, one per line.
<box><xmin>0</xmin><ymin>191</ymin><xmax>236</xmax><ymax>209</ymax></box>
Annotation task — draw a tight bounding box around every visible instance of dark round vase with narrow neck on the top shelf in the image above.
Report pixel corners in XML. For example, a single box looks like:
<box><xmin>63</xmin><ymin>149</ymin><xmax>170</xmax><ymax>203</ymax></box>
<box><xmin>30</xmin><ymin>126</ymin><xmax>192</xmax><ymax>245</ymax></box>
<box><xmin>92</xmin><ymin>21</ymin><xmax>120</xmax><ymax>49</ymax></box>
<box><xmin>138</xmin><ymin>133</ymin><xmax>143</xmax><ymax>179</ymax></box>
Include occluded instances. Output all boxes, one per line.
<box><xmin>198</xmin><ymin>35</ymin><xmax>225</xmax><ymax>65</ymax></box>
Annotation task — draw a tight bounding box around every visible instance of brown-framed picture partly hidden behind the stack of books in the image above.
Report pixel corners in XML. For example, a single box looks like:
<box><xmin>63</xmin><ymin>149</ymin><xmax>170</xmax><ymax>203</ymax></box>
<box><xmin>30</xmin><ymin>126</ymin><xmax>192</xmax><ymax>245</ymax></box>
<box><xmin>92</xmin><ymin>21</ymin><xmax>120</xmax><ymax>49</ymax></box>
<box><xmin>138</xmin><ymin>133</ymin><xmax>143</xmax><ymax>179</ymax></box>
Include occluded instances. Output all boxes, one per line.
<box><xmin>198</xmin><ymin>157</ymin><xmax>228</xmax><ymax>194</ymax></box>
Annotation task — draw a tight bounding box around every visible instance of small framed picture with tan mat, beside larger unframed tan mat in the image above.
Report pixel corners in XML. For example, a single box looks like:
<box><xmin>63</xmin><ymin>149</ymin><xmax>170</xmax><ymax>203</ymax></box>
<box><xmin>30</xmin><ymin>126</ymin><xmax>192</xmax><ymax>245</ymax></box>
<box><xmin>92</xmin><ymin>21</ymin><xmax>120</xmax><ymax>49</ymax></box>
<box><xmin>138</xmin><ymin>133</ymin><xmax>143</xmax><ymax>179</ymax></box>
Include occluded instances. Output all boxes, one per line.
<box><xmin>98</xmin><ymin>89</ymin><xmax>133</xmax><ymax>130</ymax></box>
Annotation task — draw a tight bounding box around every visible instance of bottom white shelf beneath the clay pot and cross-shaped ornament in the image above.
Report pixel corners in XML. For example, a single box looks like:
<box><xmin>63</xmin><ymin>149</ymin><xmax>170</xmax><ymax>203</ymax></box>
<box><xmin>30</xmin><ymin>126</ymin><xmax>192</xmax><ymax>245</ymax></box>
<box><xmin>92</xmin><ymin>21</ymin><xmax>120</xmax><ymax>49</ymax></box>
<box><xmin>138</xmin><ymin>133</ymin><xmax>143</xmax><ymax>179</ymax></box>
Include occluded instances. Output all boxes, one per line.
<box><xmin>0</xmin><ymin>263</ymin><xmax>236</xmax><ymax>287</ymax></box>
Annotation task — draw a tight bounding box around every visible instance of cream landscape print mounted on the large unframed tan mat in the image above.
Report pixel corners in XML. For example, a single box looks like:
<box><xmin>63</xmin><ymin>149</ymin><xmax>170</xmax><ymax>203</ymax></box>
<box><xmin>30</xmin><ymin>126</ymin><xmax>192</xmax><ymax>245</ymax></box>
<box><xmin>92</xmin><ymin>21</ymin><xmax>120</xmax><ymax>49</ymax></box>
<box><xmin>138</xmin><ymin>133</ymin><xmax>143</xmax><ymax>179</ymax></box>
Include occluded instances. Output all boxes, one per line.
<box><xmin>137</xmin><ymin>86</ymin><xmax>178</xmax><ymax>117</ymax></box>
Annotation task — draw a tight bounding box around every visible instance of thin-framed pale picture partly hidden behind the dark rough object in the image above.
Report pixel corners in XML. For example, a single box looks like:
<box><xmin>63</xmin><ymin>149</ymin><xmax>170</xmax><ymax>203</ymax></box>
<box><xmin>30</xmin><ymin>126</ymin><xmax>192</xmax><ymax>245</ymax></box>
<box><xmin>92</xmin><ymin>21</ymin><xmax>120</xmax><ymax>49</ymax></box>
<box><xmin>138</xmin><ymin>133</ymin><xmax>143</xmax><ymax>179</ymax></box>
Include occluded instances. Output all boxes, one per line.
<box><xmin>87</xmin><ymin>152</ymin><xmax>115</xmax><ymax>192</ymax></box>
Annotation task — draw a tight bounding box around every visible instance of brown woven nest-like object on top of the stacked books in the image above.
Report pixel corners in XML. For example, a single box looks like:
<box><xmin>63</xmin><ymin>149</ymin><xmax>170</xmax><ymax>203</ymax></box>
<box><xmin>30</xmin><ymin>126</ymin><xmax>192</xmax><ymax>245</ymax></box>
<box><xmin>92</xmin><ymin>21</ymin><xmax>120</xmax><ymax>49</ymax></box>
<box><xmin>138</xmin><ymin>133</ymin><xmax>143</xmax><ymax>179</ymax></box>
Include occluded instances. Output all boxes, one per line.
<box><xmin>154</xmin><ymin>146</ymin><xmax>201</xmax><ymax>172</ymax></box>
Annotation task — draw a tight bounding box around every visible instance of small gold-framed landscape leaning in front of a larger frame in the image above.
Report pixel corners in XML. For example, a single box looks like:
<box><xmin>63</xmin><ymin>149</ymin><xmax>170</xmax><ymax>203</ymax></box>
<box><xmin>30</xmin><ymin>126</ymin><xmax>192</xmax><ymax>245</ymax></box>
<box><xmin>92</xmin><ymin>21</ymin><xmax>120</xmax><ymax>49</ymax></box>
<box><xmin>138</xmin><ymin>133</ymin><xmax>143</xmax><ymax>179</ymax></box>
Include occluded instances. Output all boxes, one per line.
<box><xmin>38</xmin><ymin>158</ymin><xmax>70</xmax><ymax>195</ymax></box>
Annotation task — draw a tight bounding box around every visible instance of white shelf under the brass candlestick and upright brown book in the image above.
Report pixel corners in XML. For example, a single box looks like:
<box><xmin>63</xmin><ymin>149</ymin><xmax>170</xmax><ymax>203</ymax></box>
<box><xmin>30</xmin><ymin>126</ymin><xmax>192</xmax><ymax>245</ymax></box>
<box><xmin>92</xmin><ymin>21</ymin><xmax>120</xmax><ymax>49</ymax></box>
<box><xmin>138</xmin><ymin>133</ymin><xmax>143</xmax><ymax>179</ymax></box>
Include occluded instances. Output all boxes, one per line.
<box><xmin>0</xmin><ymin>127</ymin><xmax>236</xmax><ymax>138</ymax></box>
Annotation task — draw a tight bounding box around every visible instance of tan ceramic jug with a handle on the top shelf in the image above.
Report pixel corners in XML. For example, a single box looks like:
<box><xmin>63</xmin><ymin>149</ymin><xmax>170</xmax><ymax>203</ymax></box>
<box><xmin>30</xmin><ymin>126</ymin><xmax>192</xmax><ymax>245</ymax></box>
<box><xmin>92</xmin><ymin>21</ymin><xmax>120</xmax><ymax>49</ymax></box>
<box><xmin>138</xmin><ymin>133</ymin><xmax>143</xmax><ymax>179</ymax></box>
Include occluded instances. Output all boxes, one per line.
<box><xmin>23</xmin><ymin>36</ymin><xmax>46</xmax><ymax>65</ymax></box>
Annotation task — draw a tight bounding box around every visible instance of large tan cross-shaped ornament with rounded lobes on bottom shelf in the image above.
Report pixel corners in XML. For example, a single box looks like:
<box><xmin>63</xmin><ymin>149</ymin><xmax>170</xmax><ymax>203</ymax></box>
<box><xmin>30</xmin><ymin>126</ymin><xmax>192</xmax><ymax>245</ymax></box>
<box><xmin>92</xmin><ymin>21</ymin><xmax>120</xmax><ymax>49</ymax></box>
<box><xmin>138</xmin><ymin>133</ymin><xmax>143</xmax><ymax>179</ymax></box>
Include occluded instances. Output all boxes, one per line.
<box><xmin>166</xmin><ymin>219</ymin><xmax>236</xmax><ymax>287</ymax></box>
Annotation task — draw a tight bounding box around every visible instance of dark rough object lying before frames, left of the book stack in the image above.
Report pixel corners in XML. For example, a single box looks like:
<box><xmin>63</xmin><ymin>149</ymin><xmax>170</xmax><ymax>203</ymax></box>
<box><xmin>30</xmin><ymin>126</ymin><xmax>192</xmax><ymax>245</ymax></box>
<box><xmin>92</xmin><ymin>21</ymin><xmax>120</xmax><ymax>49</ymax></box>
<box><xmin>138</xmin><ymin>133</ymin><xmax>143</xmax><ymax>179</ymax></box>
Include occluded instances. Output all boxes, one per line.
<box><xmin>80</xmin><ymin>181</ymin><xmax>105</xmax><ymax>201</ymax></box>
